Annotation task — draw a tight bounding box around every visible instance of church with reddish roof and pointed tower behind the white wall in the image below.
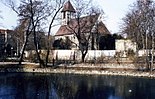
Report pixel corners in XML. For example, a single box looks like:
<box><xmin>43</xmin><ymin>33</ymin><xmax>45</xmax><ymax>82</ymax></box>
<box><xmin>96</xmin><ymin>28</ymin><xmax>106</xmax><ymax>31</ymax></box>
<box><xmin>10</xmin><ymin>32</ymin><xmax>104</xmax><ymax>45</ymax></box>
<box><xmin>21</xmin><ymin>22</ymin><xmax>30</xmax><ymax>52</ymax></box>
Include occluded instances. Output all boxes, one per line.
<box><xmin>55</xmin><ymin>0</ymin><xmax>110</xmax><ymax>50</ymax></box>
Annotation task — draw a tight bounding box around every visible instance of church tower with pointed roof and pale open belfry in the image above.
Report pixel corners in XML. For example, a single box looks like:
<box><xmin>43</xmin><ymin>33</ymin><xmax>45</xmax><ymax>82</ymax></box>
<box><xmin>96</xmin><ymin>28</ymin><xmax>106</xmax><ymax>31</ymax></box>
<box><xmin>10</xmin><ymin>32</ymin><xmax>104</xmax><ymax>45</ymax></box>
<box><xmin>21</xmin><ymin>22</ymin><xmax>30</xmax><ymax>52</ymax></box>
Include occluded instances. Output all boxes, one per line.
<box><xmin>61</xmin><ymin>0</ymin><xmax>75</xmax><ymax>25</ymax></box>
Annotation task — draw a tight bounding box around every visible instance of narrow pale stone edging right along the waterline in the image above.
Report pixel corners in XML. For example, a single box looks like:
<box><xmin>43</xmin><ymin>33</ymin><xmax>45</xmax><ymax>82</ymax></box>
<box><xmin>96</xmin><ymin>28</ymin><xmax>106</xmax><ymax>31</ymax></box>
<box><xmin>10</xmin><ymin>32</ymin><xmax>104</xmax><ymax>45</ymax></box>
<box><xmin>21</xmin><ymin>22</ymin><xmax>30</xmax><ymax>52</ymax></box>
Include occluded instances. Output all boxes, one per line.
<box><xmin>0</xmin><ymin>68</ymin><xmax>155</xmax><ymax>78</ymax></box>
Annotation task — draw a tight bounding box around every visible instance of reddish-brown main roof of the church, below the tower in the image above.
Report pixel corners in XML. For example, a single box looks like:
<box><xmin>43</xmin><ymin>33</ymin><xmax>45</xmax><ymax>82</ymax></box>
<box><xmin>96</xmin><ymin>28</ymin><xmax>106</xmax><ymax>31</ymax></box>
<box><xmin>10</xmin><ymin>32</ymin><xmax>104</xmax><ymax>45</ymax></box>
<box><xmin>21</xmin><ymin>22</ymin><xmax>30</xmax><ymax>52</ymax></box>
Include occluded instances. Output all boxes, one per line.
<box><xmin>55</xmin><ymin>14</ymin><xmax>110</xmax><ymax>36</ymax></box>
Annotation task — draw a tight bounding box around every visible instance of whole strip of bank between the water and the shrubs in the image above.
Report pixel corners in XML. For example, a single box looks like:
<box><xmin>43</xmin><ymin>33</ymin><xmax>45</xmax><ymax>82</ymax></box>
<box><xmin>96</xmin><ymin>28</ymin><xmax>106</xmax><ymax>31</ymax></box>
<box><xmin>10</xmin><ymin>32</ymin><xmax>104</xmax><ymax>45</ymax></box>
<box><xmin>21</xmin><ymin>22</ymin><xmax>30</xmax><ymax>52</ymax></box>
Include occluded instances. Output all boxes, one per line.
<box><xmin>0</xmin><ymin>63</ymin><xmax>155</xmax><ymax>78</ymax></box>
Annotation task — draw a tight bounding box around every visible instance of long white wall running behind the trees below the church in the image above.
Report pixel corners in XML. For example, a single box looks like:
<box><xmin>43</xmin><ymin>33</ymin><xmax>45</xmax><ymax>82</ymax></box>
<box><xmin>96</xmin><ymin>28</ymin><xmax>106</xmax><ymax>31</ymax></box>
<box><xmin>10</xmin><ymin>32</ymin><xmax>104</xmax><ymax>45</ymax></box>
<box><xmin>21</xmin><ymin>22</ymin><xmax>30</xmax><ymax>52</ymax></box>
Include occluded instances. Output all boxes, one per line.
<box><xmin>25</xmin><ymin>50</ymin><xmax>155</xmax><ymax>60</ymax></box>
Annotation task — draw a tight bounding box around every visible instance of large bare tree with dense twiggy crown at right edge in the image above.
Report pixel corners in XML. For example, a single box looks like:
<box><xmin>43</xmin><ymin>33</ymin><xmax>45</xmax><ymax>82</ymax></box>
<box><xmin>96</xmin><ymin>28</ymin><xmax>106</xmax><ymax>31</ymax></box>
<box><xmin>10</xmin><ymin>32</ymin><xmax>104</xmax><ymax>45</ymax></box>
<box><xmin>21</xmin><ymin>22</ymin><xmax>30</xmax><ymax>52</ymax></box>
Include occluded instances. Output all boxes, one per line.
<box><xmin>123</xmin><ymin>0</ymin><xmax>155</xmax><ymax>70</ymax></box>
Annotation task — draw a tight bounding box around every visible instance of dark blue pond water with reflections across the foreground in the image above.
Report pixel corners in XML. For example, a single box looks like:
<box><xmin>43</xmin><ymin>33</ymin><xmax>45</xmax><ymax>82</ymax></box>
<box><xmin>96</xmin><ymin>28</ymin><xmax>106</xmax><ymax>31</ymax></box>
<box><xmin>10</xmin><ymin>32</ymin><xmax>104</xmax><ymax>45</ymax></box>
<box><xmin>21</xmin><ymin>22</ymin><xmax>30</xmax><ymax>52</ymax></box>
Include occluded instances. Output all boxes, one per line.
<box><xmin>0</xmin><ymin>73</ymin><xmax>155</xmax><ymax>99</ymax></box>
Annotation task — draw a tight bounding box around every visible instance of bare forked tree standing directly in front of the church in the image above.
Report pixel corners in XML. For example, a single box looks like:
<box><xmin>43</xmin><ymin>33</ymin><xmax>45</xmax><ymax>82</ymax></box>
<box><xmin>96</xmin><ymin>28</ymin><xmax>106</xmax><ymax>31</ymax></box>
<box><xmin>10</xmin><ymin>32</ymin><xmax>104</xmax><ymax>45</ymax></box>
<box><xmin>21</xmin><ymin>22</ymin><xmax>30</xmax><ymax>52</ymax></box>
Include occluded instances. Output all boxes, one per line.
<box><xmin>67</xmin><ymin>0</ymin><xmax>99</xmax><ymax>62</ymax></box>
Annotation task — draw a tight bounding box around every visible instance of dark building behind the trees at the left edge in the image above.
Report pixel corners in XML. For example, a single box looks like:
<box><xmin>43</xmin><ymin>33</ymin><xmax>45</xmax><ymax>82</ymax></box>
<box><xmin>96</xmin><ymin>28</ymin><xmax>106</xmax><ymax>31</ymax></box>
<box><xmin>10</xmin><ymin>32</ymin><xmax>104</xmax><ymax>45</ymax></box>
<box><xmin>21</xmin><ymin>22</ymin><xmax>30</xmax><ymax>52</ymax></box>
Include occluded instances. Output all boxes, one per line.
<box><xmin>0</xmin><ymin>29</ymin><xmax>47</xmax><ymax>56</ymax></box>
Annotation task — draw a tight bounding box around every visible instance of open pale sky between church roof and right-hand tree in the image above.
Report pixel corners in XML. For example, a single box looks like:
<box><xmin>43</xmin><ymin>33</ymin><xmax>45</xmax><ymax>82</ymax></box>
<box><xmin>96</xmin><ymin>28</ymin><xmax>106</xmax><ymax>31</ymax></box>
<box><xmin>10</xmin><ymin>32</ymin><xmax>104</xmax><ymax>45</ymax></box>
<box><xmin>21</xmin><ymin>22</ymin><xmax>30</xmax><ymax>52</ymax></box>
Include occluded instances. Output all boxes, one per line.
<box><xmin>94</xmin><ymin>0</ymin><xmax>136</xmax><ymax>33</ymax></box>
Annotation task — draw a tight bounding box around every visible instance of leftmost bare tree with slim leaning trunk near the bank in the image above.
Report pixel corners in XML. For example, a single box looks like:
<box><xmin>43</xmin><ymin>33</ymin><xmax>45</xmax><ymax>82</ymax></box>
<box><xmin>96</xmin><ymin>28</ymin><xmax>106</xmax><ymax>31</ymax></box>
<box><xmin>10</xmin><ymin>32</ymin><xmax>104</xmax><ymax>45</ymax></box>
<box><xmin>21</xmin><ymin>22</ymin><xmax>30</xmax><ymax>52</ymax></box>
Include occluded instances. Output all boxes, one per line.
<box><xmin>4</xmin><ymin>0</ymin><xmax>32</xmax><ymax>64</ymax></box>
